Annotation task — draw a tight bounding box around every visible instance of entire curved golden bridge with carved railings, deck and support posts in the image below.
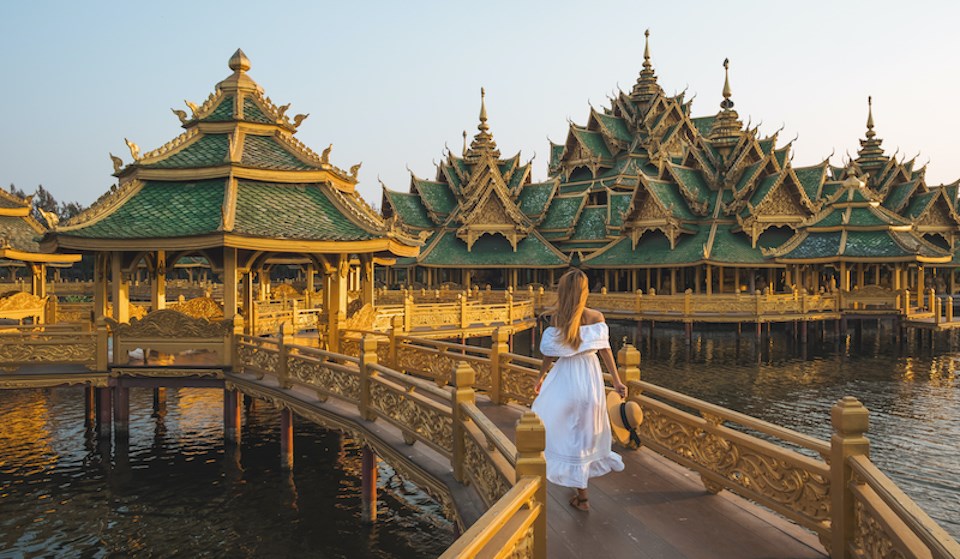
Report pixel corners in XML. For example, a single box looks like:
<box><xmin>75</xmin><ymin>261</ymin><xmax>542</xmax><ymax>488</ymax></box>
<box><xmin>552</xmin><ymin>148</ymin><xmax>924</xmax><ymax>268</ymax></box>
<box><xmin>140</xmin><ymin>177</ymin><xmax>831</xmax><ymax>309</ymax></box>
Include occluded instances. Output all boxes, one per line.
<box><xmin>0</xmin><ymin>310</ymin><xmax>960</xmax><ymax>558</ymax></box>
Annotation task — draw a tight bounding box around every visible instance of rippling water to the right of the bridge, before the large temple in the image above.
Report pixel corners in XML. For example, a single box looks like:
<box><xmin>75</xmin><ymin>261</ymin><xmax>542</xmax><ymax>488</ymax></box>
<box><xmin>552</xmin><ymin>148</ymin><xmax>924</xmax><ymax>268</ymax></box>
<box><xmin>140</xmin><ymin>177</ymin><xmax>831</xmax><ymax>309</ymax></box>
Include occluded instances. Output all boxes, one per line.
<box><xmin>611</xmin><ymin>323</ymin><xmax>960</xmax><ymax>540</ymax></box>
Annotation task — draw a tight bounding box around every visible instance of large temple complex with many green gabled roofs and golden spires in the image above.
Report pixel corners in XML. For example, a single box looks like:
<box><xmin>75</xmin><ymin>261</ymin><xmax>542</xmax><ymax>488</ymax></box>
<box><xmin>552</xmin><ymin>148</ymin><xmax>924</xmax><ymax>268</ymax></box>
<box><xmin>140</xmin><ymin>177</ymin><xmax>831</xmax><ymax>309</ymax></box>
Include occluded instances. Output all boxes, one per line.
<box><xmin>383</xmin><ymin>33</ymin><xmax>960</xmax><ymax>294</ymax></box>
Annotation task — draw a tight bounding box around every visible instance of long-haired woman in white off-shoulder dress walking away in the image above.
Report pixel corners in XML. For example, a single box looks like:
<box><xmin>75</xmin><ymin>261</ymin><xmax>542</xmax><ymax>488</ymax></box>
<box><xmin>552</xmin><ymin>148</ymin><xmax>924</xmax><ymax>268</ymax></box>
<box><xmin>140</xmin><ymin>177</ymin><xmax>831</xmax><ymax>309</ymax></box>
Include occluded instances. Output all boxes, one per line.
<box><xmin>532</xmin><ymin>269</ymin><xmax>627</xmax><ymax>511</ymax></box>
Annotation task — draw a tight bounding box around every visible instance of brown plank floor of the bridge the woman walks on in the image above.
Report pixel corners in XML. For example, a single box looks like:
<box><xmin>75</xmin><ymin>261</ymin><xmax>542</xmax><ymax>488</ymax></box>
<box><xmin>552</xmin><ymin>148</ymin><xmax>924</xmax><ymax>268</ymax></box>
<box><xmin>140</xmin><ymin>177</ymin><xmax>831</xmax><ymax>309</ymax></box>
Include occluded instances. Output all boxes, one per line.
<box><xmin>478</xmin><ymin>400</ymin><xmax>827</xmax><ymax>559</ymax></box>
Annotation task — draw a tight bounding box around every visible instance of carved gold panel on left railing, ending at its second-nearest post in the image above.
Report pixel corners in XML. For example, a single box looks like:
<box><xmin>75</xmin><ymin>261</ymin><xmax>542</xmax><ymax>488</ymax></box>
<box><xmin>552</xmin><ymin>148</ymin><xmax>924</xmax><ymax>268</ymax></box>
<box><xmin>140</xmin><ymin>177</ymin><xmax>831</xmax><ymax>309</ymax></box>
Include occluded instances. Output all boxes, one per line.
<box><xmin>370</xmin><ymin>383</ymin><xmax>453</xmax><ymax>452</ymax></box>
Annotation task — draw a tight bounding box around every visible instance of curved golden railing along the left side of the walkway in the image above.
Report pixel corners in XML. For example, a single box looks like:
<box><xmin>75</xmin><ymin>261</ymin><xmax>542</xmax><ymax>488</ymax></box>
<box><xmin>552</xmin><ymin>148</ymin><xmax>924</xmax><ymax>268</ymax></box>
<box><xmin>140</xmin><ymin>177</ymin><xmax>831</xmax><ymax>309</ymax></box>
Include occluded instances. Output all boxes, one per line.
<box><xmin>237</xmin><ymin>334</ymin><xmax>546</xmax><ymax>558</ymax></box>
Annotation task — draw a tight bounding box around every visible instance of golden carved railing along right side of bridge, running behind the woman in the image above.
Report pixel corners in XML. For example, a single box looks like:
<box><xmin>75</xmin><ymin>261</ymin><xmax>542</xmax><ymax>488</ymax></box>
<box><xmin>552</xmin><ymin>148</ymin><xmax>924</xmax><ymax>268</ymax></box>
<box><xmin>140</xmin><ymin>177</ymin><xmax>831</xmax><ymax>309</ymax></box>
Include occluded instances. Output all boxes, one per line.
<box><xmin>350</xmin><ymin>330</ymin><xmax>960</xmax><ymax>558</ymax></box>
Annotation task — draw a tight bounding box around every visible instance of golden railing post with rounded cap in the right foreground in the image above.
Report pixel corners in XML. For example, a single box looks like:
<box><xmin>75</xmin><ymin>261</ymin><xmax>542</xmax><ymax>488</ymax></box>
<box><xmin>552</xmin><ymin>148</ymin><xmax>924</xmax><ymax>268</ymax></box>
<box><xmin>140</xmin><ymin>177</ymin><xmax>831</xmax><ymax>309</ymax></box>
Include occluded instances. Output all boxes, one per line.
<box><xmin>830</xmin><ymin>396</ymin><xmax>870</xmax><ymax>559</ymax></box>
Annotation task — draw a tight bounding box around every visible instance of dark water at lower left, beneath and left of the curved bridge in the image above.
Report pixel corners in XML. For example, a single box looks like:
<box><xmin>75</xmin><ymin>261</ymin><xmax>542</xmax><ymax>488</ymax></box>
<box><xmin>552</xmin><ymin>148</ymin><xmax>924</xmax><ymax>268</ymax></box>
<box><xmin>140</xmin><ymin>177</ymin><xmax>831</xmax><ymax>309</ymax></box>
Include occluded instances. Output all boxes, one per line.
<box><xmin>0</xmin><ymin>388</ymin><xmax>454</xmax><ymax>558</ymax></box>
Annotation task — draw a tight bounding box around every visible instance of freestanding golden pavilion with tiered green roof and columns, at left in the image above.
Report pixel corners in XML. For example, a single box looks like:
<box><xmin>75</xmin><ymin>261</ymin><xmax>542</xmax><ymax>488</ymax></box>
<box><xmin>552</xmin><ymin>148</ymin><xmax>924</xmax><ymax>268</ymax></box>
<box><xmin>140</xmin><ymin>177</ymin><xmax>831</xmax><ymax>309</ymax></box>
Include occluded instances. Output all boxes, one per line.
<box><xmin>42</xmin><ymin>50</ymin><xmax>420</xmax><ymax>348</ymax></box>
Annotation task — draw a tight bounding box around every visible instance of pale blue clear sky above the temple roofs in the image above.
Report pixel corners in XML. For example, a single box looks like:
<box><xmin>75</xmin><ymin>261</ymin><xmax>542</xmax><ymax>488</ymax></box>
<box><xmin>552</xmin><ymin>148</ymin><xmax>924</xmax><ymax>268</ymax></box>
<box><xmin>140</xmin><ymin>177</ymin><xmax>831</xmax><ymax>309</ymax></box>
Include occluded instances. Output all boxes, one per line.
<box><xmin>0</xmin><ymin>0</ymin><xmax>960</xmax><ymax>209</ymax></box>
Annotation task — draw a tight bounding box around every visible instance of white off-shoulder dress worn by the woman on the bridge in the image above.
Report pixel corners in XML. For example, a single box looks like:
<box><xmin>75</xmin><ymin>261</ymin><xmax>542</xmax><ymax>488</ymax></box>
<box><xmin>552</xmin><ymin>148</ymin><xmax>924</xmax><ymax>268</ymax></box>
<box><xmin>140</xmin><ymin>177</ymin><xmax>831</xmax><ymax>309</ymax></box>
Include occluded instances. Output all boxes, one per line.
<box><xmin>531</xmin><ymin>322</ymin><xmax>623</xmax><ymax>489</ymax></box>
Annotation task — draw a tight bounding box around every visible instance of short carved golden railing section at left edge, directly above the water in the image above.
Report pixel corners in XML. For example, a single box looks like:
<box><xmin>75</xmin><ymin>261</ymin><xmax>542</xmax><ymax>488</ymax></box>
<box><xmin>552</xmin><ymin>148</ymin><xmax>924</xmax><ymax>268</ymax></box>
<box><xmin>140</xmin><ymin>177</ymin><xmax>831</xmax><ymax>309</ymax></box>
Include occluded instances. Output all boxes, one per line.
<box><xmin>0</xmin><ymin>324</ymin><xmax>98</xmax><ymax>370</ymax></box>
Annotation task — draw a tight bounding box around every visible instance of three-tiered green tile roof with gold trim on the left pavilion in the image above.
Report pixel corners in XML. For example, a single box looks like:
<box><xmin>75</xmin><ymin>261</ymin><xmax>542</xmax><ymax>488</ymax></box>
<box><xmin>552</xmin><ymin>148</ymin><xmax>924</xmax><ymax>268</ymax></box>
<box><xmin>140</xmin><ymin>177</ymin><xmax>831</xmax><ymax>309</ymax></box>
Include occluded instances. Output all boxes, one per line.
<box><xmin>47</xmin><ymin>50</ymin><xmax>420</xmax><ymax>256</ymax></box>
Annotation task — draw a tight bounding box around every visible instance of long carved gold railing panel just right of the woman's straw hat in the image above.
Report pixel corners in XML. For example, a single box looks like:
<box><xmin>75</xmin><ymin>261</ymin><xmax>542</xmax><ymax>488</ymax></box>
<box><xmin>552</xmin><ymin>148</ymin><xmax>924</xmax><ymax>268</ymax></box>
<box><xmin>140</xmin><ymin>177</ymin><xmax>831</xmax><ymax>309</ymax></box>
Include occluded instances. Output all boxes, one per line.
<box><xmin>639</xmin><ymin>408</ymin><xmax>830</xmax><ymax>522</ymax></box>
